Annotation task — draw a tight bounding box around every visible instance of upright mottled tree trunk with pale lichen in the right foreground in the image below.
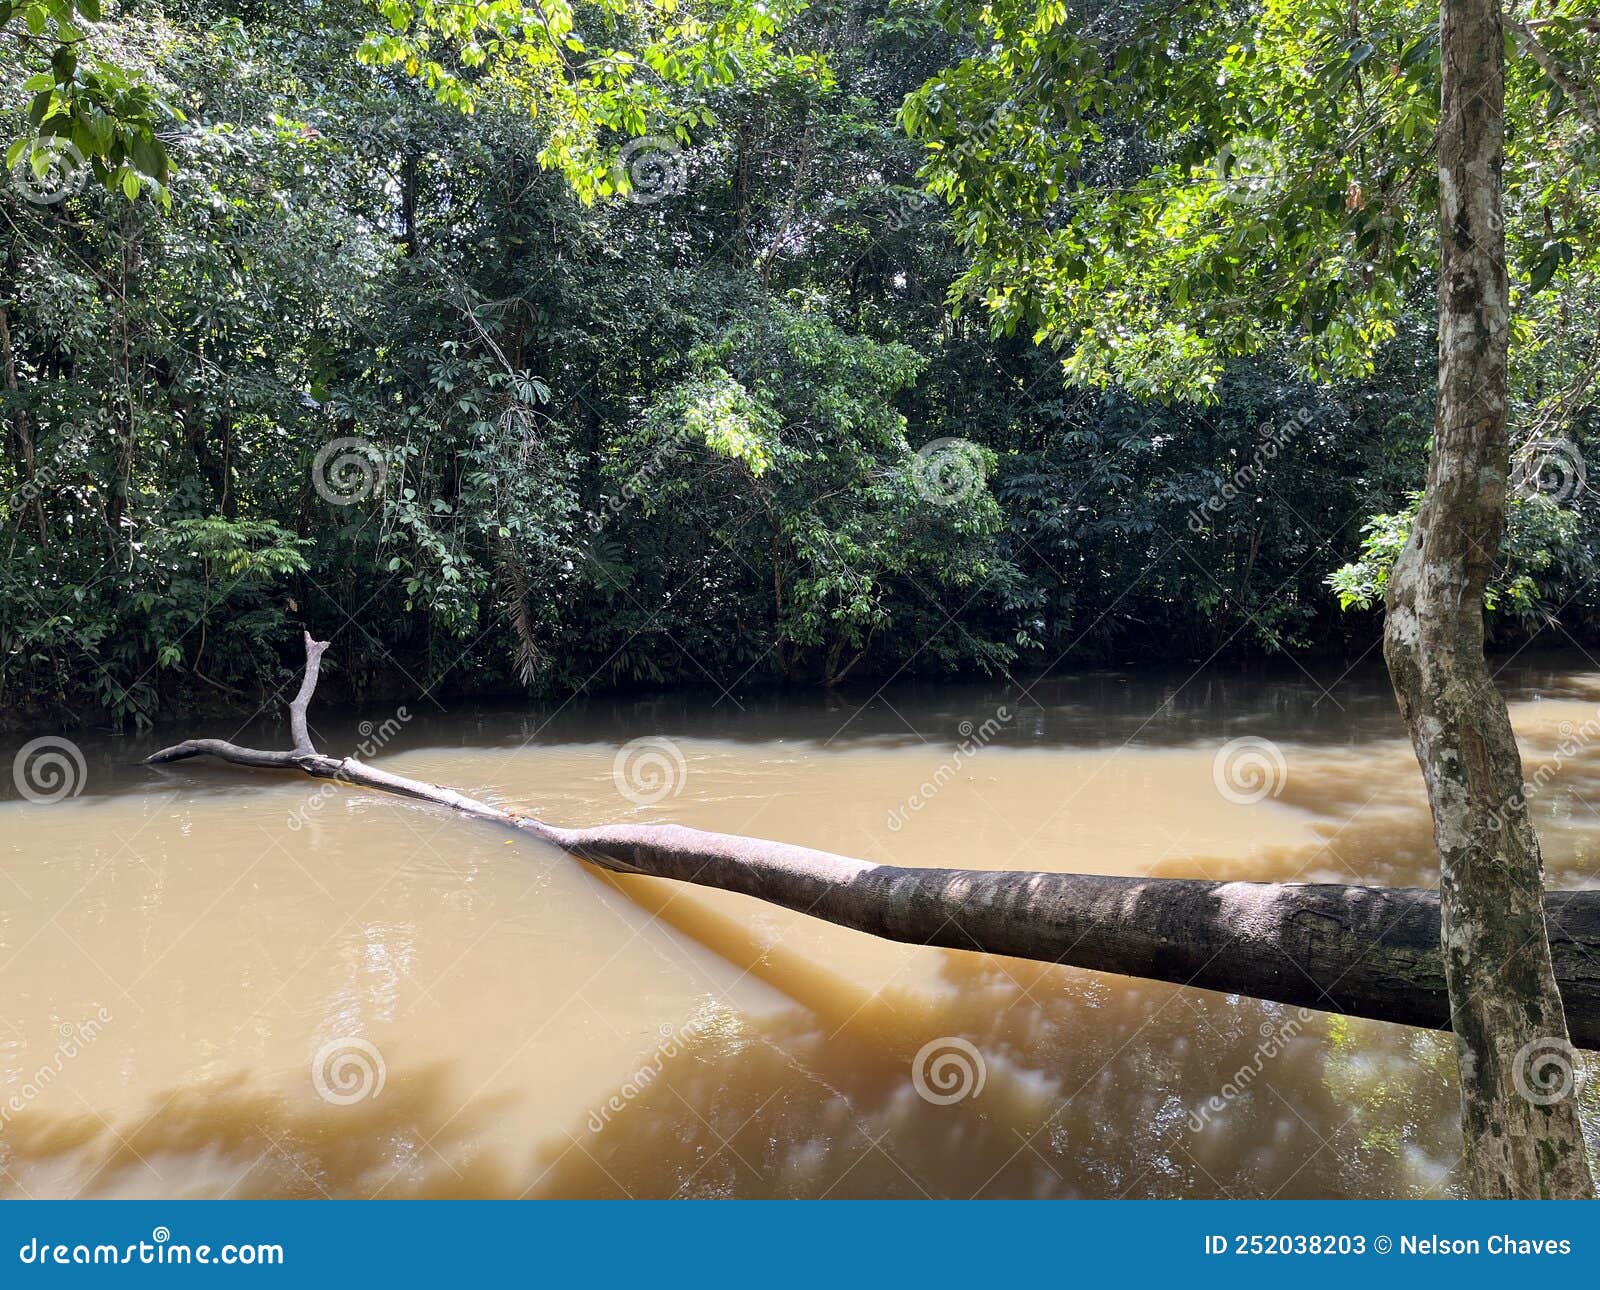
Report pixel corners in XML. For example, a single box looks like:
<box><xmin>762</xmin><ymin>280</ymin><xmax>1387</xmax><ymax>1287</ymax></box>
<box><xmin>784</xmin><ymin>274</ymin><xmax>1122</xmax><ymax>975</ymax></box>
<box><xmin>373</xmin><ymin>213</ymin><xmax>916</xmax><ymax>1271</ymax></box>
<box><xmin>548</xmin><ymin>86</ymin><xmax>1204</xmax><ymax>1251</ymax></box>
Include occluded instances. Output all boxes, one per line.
<box><xmin>1384</xmin><ymin>0</ymin><xmax>1595</xmax><ymax>1197</ymax></box>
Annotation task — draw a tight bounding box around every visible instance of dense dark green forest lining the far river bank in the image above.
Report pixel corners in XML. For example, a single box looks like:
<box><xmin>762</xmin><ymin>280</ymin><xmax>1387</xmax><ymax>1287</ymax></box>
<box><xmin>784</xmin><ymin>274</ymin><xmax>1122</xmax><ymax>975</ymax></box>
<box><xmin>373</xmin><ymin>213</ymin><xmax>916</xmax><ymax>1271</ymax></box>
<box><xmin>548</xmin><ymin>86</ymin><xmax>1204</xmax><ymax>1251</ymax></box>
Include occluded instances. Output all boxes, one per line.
<box><xmin>0</xmin><ymin>0</ymin><xmax>1600</xmax><ymax>723</ymax></box>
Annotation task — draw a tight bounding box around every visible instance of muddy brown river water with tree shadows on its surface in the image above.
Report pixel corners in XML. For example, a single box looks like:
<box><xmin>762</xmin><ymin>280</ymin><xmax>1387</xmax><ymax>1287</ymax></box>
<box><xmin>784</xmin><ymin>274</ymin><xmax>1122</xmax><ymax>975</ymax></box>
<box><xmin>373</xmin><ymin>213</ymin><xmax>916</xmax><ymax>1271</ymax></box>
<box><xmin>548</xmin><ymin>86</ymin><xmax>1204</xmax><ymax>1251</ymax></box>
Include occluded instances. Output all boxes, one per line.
<box><xmin>0</xmin><ymin>656</ymin><xmax>1600</xmax><ymax>1197</ymax></box>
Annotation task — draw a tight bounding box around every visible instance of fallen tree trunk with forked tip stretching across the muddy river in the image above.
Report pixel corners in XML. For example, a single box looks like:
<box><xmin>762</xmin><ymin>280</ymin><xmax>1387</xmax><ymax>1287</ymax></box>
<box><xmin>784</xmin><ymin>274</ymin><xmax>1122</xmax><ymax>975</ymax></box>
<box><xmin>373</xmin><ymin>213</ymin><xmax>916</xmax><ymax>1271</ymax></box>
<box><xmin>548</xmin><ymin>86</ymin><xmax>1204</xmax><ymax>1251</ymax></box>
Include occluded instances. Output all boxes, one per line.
<box><xmin>146</xmin><ymin>635</ymin><xmax>1600</xmax><ymax>1048</ymax></box>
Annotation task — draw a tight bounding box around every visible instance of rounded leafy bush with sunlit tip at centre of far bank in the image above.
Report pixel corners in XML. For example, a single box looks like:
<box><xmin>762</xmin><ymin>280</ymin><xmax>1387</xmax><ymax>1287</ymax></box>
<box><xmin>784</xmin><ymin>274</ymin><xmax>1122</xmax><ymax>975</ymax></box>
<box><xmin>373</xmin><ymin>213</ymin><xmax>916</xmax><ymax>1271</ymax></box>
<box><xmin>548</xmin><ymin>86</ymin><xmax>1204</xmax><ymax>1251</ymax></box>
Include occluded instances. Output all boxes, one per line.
<box><xmin>611</xmin><ymin>301</ymin><xmax>1011</xmax><ymax>683</ymax></box>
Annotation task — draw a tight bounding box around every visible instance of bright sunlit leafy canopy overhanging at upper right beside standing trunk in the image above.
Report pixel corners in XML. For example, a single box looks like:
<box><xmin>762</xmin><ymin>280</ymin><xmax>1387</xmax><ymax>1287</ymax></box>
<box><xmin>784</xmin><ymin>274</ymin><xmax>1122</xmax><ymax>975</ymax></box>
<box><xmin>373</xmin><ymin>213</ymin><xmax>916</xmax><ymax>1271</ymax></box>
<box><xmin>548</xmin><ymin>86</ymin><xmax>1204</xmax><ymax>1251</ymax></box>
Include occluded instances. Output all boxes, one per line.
<box><xmin>902</xmin><ymin>0</ymin><xmax>1600</xmax><ymax>399</ymax></box>
